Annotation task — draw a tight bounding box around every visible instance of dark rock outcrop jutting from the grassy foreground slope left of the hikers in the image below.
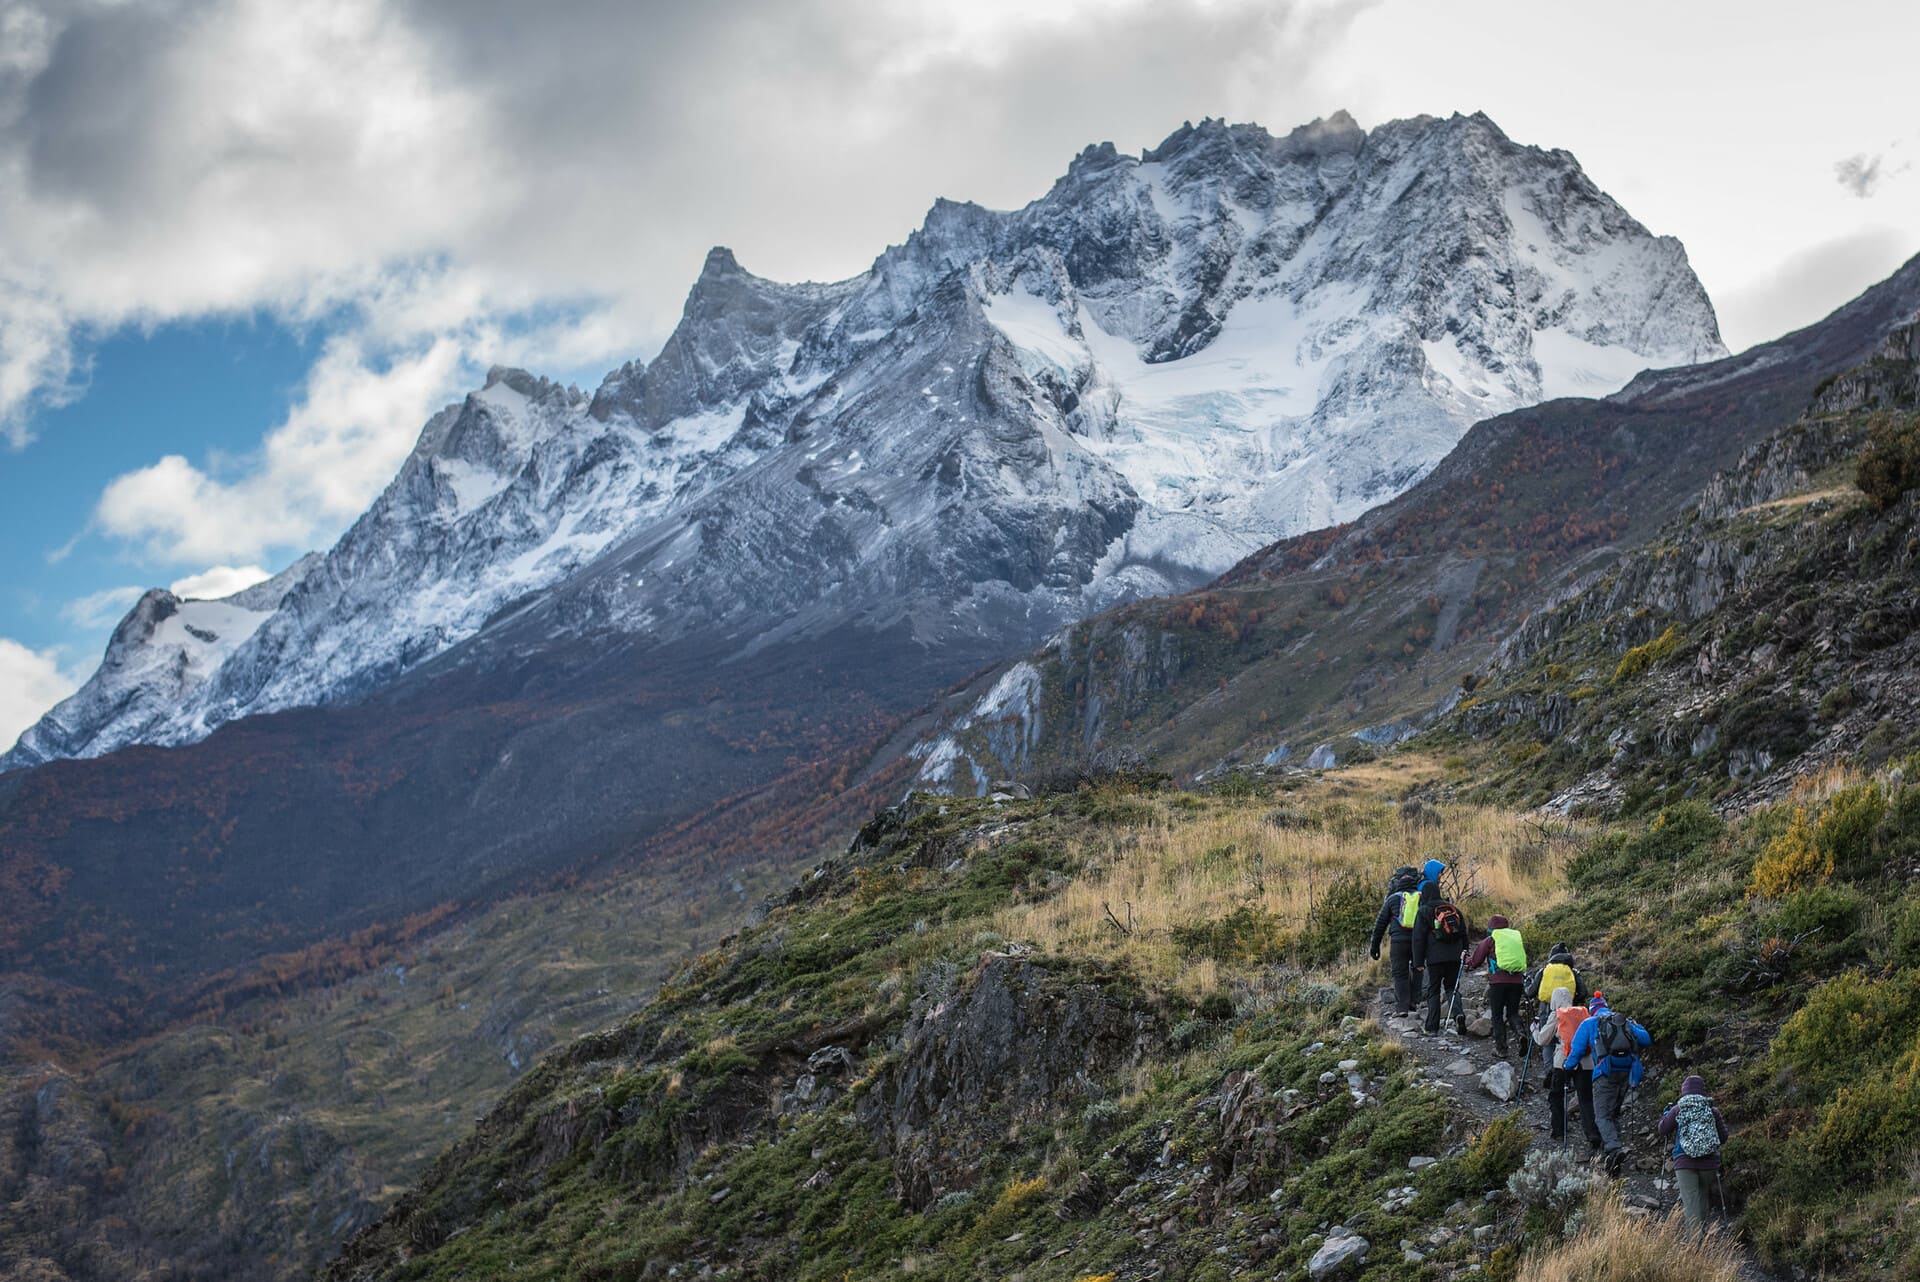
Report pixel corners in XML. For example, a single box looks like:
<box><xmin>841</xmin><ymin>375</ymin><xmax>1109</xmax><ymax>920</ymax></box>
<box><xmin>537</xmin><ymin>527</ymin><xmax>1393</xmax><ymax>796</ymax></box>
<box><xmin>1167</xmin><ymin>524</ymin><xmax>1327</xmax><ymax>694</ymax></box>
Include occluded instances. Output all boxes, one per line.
<box><xmin>864</xmin><ymin>954</ymin><xmax>1156</xmax><ymax>1207</ymax></box>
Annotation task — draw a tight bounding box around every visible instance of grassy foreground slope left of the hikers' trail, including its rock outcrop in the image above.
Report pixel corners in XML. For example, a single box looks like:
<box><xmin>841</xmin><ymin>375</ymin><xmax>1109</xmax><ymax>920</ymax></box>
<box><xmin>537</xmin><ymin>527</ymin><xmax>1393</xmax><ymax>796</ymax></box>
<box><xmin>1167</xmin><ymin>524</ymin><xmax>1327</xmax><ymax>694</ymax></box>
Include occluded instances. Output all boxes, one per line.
<box><xmin>332</xmin><ymin>760</ymin><xmax>1589</xmax><ymax>1280</ymax></box>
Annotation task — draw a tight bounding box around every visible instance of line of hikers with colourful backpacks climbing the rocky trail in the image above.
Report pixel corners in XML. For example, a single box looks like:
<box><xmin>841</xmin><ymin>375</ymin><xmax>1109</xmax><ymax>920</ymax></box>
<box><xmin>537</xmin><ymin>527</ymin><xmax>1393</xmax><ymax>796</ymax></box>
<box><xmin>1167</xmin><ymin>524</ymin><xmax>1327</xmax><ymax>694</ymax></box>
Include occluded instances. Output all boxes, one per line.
<box><xmin>1369</xmin><ymin>858</ymin><xmax>1726</xmax><ymax>1226</ymax></box>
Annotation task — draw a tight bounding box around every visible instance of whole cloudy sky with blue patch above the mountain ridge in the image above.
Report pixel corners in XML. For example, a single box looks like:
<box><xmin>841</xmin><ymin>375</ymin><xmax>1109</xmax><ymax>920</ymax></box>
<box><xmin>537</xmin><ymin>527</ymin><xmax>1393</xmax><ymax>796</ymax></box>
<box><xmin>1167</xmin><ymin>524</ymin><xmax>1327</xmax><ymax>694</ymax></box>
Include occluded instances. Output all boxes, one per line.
<box><xmin>0</xmin><ymin>0</ymin><xmax>1920</xmax><ymax>745</ymax></box>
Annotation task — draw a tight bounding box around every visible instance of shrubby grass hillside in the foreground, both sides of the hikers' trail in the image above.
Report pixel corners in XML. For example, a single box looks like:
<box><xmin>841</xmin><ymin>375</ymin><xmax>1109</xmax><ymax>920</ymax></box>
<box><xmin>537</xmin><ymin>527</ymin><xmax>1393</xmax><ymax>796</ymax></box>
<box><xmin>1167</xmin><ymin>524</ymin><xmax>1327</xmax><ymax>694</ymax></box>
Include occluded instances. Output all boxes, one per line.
<box><xmin>328</xmin><ymin>740</ymin><xmax>1920</xmax><ymax>1282</ymax></box>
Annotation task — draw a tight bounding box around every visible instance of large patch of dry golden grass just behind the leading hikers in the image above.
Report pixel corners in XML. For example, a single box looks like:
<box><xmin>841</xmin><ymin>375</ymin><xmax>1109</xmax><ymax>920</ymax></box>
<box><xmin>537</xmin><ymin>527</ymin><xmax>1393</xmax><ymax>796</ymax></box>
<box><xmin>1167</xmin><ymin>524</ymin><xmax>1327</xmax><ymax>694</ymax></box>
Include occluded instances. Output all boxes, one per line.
<box><xmin>995</xmin><ymin>758</ymin><xmax>1565</xmax><ymax>994</ymax></box>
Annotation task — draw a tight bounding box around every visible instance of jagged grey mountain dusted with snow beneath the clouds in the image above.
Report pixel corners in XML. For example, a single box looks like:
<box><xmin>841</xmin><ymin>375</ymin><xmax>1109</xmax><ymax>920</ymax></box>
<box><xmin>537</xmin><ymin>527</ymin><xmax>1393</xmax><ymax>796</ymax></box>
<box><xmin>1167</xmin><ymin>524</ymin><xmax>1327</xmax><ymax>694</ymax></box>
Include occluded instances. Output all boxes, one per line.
<box><xmin>0</xmin><ymin>113</ymin><xmax>1724</xmax><ymax>768</ymax></box>
